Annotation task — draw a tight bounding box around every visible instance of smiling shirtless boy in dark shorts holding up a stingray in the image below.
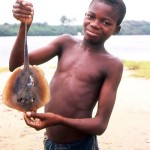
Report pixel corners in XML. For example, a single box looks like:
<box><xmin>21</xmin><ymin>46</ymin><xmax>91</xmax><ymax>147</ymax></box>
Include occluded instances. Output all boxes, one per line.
<box><xmin>10</xmin><ymin>0</ymin><xmax>126</xmax><ymax>150</ymax></box>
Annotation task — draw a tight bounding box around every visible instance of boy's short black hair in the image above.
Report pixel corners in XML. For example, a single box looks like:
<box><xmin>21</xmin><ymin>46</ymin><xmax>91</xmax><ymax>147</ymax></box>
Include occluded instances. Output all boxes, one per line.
<box><xmin>90</xmin><ymin>0</ymin><xmax>126</xmax><ymax>25</ymax></box>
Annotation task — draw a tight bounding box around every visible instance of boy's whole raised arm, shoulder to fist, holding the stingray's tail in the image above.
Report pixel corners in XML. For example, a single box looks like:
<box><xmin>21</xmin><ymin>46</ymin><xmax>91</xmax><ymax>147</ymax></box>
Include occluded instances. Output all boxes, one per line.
<box><xmin>9</xmin><ymin>0</ymin><xmax>66</xmax><ymax>71</ymax></box>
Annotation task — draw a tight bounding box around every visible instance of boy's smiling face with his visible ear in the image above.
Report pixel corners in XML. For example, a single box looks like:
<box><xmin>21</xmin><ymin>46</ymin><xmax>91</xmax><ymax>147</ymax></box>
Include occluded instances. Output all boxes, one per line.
<box><xmin>83</xmin><ymin>2</ymin><xmax>120</xmax><ymax>43</ymax></box>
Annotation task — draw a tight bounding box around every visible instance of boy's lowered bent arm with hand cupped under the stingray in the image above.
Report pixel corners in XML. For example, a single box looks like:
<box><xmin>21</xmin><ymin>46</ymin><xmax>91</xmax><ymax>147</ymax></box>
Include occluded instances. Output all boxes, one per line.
<box><xmin>24</xmin><ymin>60</ymin><xmax>123</xmax><ymax>135</ymax></box>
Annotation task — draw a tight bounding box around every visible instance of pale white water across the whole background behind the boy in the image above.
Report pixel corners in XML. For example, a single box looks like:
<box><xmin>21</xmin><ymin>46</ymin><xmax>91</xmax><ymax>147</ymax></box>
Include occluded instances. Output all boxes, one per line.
<box><xmin>0</xmin><ymin>35</ymin><xmax>150</xmax><ymax>67</ymax></box>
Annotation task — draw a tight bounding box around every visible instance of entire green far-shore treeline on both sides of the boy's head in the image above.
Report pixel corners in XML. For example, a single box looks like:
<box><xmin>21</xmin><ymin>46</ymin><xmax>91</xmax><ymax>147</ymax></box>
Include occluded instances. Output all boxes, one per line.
<box><xmin>0</xmin><ymin>20</ymin><xmax>150</xmax><ymax>36</ymax></box>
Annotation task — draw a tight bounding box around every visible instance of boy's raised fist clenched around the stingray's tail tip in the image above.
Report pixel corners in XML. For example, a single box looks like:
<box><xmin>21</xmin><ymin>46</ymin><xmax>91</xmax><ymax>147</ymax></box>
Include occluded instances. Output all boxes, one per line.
<box><xmin>12</xmin><ymin>0</ymin><xmax>34</xmax><ymax>24</ymax></box>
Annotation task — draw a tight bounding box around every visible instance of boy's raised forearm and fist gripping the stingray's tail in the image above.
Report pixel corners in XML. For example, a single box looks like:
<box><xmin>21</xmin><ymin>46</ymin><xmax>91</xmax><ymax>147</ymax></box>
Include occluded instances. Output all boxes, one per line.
<box><xmin>9</xmin><ymin>0</ymin><xmax>34</xmax><ymax>71</ymax></box>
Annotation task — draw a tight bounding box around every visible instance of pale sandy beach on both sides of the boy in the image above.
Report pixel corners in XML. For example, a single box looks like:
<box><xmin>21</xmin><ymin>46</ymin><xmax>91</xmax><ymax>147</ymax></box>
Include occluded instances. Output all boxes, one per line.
<box><xmin>0</xmin><ymin>67</ymin><xmax>150</xmax><ymax>150</ymax></box>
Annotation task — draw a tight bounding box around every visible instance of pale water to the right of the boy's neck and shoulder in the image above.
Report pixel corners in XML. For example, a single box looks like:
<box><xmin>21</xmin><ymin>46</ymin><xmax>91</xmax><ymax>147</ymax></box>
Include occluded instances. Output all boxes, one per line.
<box><xmin>106</xmin><ymin>36</ymin><xmax>150</xmax><ymax>61</ymax></box>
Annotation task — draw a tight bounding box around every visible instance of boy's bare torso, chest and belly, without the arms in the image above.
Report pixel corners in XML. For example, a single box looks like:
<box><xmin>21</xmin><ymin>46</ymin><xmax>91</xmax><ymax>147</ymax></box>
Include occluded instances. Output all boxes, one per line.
<box><xmin>45</xmin><ymin>37</ymin><xmax>112</xmax><ymax>143</ymax></box>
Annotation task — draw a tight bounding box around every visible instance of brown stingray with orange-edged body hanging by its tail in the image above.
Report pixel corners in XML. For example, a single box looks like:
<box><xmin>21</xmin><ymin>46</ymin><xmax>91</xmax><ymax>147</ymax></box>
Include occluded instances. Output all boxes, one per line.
<box><xmin>2</xmin><ymin>23</ymin><xmax>50</xmax><ymax>112</ymax></box>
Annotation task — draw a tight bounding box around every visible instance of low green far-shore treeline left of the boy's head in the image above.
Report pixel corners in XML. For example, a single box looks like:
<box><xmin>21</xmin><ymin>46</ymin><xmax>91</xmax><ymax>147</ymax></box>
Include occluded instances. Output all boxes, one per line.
<box><xmin>0</xmin><ymin>23</ymin><xmax>82</xmax><ymax>36</ymax></box>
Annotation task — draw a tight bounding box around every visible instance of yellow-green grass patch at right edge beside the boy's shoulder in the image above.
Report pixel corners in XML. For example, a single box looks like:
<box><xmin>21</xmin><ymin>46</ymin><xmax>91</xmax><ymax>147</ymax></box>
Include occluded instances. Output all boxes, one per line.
<box><xmin>123</xmin><ymin>60</ymin><xmax>150</xmax><ymax>79</ymax></box>
